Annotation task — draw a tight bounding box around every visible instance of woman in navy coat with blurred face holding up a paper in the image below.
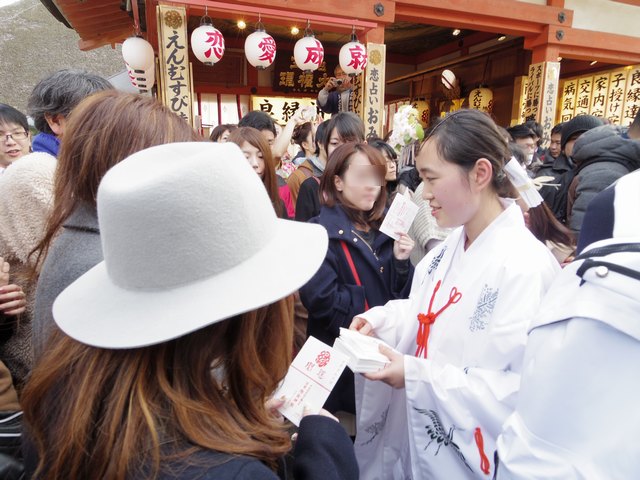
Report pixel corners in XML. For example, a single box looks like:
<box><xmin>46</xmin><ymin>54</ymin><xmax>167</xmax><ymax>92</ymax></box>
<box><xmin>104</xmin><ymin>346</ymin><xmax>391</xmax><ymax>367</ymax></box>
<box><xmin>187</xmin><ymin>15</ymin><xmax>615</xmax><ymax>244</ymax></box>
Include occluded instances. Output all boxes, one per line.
<box><xmin>300</xmin><ymin>142</ymin><xmax>413</xmax><ymax>413</ymax></box>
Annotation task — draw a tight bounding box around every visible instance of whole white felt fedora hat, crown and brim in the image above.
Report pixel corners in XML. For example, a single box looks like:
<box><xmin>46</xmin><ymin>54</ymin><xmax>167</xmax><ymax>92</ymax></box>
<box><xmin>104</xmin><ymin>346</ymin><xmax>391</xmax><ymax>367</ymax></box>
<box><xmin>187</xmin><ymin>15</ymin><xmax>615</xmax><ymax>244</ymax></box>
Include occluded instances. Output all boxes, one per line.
<box><xmin>53</xmin><ymin>142</ymin><xmax>328</xmax><ymax>348</ymax></box>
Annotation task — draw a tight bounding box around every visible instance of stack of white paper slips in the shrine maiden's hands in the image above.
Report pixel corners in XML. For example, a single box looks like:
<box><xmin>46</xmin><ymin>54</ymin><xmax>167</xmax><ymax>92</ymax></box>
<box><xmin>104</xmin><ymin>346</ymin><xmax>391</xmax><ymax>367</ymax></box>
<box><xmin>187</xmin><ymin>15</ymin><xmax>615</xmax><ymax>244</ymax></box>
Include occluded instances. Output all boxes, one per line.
<box><xmin>333</xmin><ymin>328</ymin><xmax>390</xmax><ymax>373</ymax></box>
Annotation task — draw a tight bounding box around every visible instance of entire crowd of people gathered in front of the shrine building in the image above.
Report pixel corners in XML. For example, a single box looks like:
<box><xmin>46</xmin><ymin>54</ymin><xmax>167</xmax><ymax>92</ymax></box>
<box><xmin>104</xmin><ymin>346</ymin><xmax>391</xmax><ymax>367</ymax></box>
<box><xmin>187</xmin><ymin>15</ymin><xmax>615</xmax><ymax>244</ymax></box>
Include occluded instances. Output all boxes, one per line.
<box><xmin>0</xmin><ymin>70</ymin><xmax>640</xmax><ymax>480</ymax></box>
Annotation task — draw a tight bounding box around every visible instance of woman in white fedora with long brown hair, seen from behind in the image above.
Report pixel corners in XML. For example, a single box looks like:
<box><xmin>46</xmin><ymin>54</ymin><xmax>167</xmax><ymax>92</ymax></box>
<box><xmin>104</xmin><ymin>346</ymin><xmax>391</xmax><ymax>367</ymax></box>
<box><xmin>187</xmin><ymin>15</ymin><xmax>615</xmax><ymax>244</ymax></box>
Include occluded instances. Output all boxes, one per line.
<box><xmin>24</xmin><ymin>142</ymin><xmax>358</xmax><ymax>480</ymax></box>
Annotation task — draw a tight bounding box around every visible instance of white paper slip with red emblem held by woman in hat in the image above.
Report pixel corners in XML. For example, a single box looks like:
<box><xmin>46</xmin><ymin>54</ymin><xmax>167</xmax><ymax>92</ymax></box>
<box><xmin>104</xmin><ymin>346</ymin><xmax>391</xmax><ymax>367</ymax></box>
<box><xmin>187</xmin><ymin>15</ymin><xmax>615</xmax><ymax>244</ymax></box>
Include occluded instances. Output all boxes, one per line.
<box><xmin>273</xmin><ymin>337</ymin><xmax>347</xmax><ymax>426</ymax></box>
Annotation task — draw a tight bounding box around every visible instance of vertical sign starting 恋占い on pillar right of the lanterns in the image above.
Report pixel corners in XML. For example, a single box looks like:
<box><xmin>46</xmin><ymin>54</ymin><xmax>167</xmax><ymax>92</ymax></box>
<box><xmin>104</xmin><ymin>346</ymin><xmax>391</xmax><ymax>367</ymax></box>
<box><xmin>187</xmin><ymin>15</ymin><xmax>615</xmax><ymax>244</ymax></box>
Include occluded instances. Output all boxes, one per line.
<box><xmin>364</xmin><ymin>43</ymin><xmax>386</xmax><ymax>138</ymax></box>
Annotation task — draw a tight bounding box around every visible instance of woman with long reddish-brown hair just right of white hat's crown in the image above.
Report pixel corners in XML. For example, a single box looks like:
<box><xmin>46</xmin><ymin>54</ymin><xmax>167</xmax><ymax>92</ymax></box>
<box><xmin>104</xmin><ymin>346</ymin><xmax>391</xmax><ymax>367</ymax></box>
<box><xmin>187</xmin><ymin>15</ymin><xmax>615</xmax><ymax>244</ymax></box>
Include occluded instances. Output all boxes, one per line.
<box><xmin>228</xmin><ymin>127</ymin><xmax>289</xmax><ymax>218</ymax></box>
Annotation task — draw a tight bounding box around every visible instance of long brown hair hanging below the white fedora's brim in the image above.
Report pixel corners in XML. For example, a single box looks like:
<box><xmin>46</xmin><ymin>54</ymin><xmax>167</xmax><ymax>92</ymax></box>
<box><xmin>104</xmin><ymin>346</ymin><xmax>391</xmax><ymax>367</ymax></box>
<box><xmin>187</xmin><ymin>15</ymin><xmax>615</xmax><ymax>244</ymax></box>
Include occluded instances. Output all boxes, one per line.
<box><xmin>21</xmin><ymin>297</ymin><xmax>293</xmax><ymax>479</ymax></box>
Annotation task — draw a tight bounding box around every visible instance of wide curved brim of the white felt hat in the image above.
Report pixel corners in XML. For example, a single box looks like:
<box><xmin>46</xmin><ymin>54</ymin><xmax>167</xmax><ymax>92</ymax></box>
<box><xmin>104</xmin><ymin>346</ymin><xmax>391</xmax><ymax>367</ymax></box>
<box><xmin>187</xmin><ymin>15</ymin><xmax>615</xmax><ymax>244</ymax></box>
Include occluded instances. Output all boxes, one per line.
<box><xmin>53</xmin><ymin>219</ymin><xmax>328</xmax><ymax>349</ymax></box>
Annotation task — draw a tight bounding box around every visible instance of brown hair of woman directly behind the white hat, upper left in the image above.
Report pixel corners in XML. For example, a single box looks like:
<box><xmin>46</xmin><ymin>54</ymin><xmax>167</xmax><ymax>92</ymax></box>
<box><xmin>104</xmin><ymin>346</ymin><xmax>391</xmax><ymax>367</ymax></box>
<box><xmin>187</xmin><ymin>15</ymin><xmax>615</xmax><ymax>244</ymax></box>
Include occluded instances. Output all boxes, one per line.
<box><xmin>31</xmin><ymin>90</ymin><xmax>203</xmax><ymax>279</ymax></box>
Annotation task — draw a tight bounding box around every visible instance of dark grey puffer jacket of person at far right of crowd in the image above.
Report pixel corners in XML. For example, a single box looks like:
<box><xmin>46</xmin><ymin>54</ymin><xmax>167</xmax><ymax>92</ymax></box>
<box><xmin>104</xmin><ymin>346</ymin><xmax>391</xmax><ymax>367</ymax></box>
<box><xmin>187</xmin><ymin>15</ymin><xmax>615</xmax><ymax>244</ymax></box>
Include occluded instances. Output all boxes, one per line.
<box><xmin>567</xmin><ymin>125</ymin><xmax>640</xmax><ymax>234</ymax></box>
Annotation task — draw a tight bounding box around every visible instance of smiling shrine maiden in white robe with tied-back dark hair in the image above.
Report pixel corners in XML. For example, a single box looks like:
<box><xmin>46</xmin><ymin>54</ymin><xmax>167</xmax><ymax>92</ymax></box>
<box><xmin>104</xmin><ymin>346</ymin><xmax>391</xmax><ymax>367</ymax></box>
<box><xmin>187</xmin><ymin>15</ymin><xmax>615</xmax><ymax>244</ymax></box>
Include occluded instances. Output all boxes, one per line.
<box><xmin>351</xmin><ymin>110</ymin><xmax>560</xmax><ymax>479</ymax></box>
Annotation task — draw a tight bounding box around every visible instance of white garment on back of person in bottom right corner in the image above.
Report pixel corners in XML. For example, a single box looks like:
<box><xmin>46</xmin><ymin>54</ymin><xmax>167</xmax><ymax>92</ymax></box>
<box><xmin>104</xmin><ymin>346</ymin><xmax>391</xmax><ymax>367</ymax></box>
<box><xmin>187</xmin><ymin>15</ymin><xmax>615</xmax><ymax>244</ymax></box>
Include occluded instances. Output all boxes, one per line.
<box><xmin>497</xmin><ymin>237</ymin><xmax>640</xmax><ymax>480</ymax></box>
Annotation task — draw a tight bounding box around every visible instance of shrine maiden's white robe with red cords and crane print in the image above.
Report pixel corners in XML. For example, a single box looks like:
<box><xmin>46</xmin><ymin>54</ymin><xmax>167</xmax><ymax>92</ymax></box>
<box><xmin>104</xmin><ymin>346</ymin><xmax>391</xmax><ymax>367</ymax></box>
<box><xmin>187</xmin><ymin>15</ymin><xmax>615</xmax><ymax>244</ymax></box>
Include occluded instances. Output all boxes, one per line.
<box><xmin>355</xmin><ymin>200</ymin><xmax>559</xmax><ymax>480</ymax></box>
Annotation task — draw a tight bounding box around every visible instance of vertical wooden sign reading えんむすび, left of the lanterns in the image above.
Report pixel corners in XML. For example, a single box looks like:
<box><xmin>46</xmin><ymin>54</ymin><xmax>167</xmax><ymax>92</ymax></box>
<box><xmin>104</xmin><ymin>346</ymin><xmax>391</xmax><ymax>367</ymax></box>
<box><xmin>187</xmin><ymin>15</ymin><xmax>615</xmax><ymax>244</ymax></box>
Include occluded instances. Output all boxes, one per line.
<box><xmin>157</xmin><ymin>5</ymin><xmax>192</xmax><ymax>126</ymax></box>
